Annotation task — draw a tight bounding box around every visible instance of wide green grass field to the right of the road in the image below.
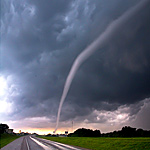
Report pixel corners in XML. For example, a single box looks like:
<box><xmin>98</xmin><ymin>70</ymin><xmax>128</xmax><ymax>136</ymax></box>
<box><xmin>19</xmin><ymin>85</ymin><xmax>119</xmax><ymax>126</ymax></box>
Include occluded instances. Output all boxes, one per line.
<box><xmin>41</xmin><ymin>137</ymin><xmax>150</xmax><ymax>150</ymax></box>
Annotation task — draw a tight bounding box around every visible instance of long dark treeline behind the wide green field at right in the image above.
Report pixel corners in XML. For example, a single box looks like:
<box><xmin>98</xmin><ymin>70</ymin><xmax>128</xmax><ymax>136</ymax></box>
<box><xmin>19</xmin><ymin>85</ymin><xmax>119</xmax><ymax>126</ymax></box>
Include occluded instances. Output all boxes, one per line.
<box><xmin>68</xmin><ymin>126</ymin><xmax>150</xmax><ymax>137</ymax></box>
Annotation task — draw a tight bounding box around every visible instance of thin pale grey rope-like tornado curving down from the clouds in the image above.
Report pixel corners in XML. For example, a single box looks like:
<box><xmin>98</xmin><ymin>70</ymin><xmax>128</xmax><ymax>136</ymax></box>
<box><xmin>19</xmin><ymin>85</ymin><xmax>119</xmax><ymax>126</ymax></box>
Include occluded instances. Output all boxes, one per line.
<box><xmin>54</xmin><ymin>0</ymin><xmax>150</xmax><ymax>132</ymax></box>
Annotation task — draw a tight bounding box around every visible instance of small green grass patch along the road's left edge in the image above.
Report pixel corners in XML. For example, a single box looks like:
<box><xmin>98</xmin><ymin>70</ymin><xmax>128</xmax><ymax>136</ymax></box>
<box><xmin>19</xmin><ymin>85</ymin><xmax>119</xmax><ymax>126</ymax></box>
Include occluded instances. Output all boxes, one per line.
<box><xmin>0</xmin><ymin>134</ymin><xmax>20</xmax><ymax>148</ymax></box>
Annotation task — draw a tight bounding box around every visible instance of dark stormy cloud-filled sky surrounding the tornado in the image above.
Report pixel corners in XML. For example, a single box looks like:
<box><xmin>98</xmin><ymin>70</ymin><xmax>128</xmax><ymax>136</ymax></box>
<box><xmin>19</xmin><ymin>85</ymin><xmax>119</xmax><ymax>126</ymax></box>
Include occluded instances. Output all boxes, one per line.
<box><xmin>0</xmin><ymin>0</ymin><xmax>150</xmax><ymax>134</ymax></box>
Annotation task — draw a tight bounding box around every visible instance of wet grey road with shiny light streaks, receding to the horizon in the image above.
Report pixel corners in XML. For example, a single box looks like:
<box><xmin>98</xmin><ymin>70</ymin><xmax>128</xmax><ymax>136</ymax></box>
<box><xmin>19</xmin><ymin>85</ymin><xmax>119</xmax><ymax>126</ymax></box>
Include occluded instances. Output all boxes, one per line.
<box><xmin>1</xmin><ymin>136</ymin><xmax>83</xmax><ymax>150</ymax></box>
